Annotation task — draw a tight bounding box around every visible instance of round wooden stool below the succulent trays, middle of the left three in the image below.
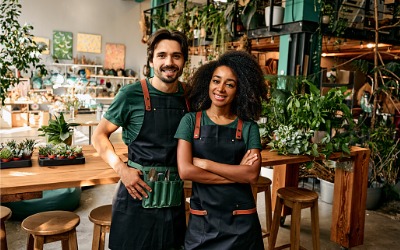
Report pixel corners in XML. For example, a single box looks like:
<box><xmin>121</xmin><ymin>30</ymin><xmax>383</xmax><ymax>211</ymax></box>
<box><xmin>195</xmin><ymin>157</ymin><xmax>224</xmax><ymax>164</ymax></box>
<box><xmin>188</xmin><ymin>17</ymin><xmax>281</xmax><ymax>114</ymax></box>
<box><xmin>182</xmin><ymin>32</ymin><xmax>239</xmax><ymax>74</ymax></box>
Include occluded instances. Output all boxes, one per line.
<box><xmin>21</xmin><ymin>211</ymin><xmax>80</xmax><ymax>250</ymax></box>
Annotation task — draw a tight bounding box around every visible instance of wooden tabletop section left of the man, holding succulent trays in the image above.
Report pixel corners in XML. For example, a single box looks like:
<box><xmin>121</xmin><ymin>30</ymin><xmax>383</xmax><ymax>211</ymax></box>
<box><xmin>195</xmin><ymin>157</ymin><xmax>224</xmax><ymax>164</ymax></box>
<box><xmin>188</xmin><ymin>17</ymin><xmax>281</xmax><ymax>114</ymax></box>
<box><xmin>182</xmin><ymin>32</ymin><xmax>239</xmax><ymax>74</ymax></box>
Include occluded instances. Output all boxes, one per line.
<box><xmin>0</xmin><ymin>143</ymin><xmax>128</xmax><ymax>202</ymax></box>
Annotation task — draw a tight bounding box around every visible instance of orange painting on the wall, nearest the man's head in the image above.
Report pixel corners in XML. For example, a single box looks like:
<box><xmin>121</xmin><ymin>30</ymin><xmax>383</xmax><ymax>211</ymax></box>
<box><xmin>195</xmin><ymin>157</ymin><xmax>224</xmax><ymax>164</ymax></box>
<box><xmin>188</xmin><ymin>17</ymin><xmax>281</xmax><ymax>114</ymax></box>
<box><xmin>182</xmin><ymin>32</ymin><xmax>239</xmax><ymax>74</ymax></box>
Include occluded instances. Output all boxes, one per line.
<box><xmin>104</xmin><ymin>43</ymin><xmax>125</xmax><ymax>70</ymax></box>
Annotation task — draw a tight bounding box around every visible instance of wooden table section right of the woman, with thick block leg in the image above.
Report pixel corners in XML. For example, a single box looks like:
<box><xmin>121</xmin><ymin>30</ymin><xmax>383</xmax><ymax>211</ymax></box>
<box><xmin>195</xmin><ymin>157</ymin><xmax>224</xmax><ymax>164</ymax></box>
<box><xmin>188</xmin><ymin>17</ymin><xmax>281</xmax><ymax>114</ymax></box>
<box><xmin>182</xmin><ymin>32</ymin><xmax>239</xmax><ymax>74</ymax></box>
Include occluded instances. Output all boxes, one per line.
<box><xmin>261</xmin><ymin>147</ymin><xmax>370</xmax><ymax>248</ymax></box>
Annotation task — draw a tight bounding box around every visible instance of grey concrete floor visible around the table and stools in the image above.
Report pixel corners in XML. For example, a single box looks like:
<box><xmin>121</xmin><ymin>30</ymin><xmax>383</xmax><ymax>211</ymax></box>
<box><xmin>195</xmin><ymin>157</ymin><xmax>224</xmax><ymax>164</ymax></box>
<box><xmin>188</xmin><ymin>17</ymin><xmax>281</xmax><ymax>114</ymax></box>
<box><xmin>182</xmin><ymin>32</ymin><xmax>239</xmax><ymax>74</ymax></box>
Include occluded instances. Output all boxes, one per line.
<box><xmin>0</xmin><ymin>124</ymin><xmax>400</xmax><ymax>250</ymax></box>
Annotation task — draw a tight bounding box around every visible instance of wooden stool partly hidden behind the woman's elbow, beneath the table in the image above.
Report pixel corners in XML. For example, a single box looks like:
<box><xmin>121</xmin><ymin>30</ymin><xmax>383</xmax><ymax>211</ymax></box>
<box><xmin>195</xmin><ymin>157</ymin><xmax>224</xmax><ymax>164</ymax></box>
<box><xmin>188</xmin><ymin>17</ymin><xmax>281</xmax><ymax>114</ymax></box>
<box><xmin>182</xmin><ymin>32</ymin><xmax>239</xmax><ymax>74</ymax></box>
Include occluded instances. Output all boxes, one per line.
<box><xmin>252</xmin><ymin>176</ymin><xmax>272</xmax><ymax>238</ymax></box>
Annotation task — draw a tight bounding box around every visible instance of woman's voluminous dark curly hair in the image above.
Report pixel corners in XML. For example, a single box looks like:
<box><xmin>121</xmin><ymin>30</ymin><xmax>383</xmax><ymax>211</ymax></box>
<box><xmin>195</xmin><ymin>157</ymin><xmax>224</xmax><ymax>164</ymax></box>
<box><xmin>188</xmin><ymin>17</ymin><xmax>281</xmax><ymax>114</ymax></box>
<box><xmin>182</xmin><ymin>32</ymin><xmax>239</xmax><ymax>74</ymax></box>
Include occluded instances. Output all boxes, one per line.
<box><xmin>189</xmin><ymin>51</ymin><xmax>267</xmax><ymax>121</ymax></box>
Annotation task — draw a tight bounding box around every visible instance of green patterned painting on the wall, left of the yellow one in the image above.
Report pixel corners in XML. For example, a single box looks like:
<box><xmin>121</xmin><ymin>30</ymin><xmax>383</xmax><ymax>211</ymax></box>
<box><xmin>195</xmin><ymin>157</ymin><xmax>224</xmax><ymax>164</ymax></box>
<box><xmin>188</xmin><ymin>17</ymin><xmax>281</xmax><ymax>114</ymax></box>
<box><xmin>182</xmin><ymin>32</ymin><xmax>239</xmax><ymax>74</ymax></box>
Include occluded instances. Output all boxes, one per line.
<box><xmin>53</xmin><ymin>31</ymin><xmax>73</xmax><ymax>60</ymax></box>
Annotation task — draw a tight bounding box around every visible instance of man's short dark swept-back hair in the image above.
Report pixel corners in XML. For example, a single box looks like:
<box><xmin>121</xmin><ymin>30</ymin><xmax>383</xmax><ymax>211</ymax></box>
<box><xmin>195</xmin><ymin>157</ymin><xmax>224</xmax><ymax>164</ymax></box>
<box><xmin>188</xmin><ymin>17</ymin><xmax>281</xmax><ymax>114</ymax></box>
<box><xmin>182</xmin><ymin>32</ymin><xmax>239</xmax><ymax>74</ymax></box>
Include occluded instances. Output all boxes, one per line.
<box><xmin>147</xmin><ymin>29</ymin><xmax>189</xmax><ymax>63</ymax></box>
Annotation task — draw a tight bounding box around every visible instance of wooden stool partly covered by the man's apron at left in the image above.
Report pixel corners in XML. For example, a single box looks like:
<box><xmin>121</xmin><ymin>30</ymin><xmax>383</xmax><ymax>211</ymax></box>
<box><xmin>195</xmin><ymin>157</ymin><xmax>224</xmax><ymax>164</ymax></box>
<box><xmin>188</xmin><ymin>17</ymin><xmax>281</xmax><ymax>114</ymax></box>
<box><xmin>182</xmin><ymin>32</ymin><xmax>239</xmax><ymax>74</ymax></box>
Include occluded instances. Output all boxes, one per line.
<box><xmin>89</xmin><ymin>205</ymin><xmax>112</xmax><ymax>250</ymax></box>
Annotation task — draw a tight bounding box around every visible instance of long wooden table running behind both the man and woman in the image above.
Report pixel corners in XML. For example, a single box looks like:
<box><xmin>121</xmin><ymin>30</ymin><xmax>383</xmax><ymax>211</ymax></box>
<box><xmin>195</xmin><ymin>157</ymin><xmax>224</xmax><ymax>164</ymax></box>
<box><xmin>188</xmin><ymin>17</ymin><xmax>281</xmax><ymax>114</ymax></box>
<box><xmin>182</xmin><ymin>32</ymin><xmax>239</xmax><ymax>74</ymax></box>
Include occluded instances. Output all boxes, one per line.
<box><xmin>0</xmin><ymin>143</ymin><xmax>369</xmax><ymax>248</ymax></box>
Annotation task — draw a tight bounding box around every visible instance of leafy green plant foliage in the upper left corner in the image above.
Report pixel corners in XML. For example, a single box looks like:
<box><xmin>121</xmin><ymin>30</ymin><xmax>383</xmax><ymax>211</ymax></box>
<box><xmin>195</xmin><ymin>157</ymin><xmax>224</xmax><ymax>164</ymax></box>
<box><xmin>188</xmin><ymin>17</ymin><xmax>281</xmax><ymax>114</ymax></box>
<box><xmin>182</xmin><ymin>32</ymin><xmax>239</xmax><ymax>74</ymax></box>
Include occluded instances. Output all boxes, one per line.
<box><xmin>0</xmin><ymin>0</ymin><xmax>47</xmax><ymax>104</ymax></box>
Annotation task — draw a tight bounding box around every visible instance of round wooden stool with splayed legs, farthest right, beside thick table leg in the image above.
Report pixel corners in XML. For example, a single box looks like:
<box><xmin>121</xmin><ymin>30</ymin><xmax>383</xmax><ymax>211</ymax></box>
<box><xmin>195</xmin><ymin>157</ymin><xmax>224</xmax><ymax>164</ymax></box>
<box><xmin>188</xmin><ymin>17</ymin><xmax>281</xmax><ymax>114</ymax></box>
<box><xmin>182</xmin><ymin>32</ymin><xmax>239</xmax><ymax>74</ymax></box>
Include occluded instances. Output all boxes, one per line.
<box><xmin>268</xmin><ymin>187</ymin><xmax>320</xmax><ymax>250</ymax></box>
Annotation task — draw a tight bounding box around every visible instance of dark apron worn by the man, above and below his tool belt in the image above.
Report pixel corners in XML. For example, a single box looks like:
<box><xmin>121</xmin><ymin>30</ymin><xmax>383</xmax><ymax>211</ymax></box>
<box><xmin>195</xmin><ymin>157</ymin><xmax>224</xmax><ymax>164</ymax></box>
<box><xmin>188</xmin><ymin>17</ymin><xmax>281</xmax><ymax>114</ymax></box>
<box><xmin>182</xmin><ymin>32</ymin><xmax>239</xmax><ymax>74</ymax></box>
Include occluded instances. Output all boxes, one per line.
<box><xmin>109</xmin><ymin>81</ymin><xmax>186</xmax><ymax>250</ymax></box>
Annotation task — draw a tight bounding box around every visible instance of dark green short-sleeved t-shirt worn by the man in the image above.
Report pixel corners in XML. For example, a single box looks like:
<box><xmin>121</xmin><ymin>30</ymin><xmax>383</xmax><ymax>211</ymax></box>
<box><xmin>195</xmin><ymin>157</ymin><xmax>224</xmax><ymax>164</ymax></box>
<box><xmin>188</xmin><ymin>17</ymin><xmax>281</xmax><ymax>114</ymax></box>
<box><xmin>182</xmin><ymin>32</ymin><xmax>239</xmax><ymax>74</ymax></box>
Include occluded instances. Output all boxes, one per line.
<box><xmin>104</xmin><ymin>79</ymin><xmax>183</xmax><ymax>145</ymax></box>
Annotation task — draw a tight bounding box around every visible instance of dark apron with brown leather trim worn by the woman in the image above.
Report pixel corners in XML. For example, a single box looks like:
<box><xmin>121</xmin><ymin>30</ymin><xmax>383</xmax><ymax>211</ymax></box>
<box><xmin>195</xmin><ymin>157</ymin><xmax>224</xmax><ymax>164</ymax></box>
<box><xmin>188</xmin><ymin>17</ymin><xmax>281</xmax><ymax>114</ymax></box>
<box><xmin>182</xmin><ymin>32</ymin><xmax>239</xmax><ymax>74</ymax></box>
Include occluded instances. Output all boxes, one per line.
<box><xmin>185</xmin><ymin>114</ymin><xmax>264</xmax><ymax>250</ymax></box>
